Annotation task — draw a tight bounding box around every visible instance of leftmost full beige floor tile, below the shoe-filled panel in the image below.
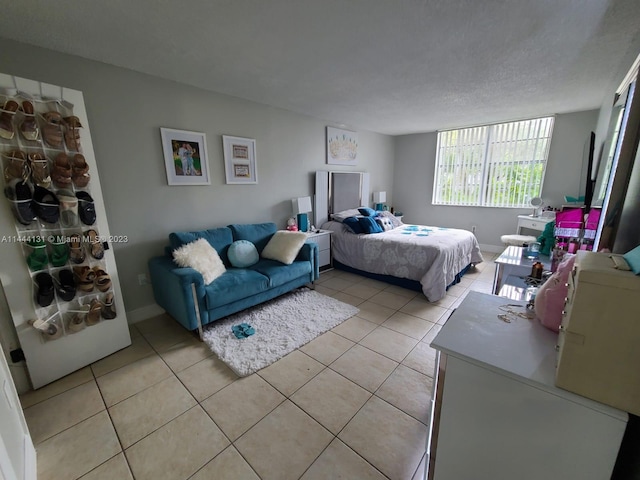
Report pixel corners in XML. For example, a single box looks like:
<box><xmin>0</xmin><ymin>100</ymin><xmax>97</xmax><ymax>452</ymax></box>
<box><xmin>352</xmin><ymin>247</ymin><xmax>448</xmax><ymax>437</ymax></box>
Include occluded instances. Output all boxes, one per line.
<box><xmin>24</xmin><ymin>381</ymin><xmax>105</xmax><ymax>445</ymax></box>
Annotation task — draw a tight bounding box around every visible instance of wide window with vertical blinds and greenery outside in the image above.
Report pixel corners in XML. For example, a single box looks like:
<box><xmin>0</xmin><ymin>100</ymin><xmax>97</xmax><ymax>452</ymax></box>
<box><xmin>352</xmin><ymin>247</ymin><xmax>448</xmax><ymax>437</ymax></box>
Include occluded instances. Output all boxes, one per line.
<box><xmin>433</xmin><ymin>117</ymin><xmax>553</xmax><ymax>207</ymax></box>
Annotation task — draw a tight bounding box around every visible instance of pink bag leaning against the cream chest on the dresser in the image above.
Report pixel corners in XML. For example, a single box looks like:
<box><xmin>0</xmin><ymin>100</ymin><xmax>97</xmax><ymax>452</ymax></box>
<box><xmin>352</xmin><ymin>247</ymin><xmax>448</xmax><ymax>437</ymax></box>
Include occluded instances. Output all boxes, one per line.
<box><xmin>534</xmin><ymin>253</ymin><xmax>576</xmax><ymax>332</ymax></box>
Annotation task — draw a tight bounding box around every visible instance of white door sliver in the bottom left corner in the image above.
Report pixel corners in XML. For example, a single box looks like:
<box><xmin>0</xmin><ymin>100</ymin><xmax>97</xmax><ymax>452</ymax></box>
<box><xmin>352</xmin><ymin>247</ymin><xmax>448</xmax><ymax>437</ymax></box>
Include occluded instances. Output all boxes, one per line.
<box><xmin>0</xmin><ymin>346</ymin><xmax>36</xmax><ymax>480</ymax></box>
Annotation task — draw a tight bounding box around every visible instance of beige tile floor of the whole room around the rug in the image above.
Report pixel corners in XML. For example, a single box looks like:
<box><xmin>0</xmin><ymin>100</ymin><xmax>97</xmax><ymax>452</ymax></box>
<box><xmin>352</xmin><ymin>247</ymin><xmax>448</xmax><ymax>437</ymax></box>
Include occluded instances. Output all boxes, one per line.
<box><xmin>21</xmin><ymin>253</ymin><xmax>497</xmax><ymax>480</ymax></box>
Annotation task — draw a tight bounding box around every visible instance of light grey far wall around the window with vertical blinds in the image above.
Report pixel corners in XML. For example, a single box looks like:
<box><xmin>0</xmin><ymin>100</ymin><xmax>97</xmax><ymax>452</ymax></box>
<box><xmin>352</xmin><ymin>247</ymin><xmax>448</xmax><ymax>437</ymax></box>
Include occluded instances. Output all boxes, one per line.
<box><xmin>393</xmin><ymin>110</ymin><xmax>598</xmax><ymax>246</ymax></box>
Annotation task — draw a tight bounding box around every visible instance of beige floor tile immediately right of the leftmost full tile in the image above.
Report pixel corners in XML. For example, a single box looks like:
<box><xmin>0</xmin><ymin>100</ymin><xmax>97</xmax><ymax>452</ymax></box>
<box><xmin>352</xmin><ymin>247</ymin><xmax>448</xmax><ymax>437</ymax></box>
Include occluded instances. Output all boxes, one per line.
<box><xmin>96</xmin><ymin>355</ymin><xmax>172</xmax><ymax>407</ymax></box>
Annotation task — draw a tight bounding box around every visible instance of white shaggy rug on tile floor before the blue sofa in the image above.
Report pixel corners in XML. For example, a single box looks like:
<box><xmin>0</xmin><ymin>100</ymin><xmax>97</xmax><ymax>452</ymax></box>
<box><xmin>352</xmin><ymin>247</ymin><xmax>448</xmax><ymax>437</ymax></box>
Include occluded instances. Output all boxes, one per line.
<box><xmin>204</xmin><ymin>288</ymin><xmax>360</xmax><ymax>377</ymax></box>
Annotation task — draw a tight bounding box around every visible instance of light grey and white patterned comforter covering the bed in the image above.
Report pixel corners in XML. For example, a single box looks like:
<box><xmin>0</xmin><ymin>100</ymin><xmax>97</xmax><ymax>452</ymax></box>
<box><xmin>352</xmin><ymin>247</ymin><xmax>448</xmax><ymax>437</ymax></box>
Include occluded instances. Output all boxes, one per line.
<box><xmin>322</xmin><ymin>221</ymin><xmax>482</xmax><ymax>302</ymax></box>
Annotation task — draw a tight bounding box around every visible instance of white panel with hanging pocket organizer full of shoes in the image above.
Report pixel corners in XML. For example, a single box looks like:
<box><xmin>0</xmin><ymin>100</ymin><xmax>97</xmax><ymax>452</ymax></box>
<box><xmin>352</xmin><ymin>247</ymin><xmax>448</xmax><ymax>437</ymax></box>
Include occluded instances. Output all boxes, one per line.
<box><xmin>0</xmin><ymin>74</ymin><xmax>131</xmax><ymax>388</ymax></box>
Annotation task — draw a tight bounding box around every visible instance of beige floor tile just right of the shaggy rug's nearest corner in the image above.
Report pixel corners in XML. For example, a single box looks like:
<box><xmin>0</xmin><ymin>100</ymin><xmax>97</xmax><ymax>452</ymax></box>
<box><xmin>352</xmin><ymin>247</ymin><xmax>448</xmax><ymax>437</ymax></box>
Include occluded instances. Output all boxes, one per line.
<box><xmin>258</xmin><ymin>350</ymin><xmax>324</xmax><ymax>397</ymax></box>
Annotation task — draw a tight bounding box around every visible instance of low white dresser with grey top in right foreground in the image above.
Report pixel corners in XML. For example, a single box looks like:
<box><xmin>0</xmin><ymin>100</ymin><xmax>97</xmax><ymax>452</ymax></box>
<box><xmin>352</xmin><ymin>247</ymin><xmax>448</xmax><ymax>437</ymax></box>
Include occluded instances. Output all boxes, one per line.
<box><xmin>426</xmin><ymin>292</ymin><xmax>628</xmax><ymax>480</ymax></box>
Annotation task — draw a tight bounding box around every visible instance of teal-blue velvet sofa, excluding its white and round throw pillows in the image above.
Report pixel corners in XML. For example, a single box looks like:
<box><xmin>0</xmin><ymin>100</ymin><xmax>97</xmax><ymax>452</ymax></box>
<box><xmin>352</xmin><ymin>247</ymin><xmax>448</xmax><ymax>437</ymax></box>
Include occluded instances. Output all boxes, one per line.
<box><xmin>149</xmin><ymin>223</ymin><xmax>320</xmax><ymax>337</ymax></box>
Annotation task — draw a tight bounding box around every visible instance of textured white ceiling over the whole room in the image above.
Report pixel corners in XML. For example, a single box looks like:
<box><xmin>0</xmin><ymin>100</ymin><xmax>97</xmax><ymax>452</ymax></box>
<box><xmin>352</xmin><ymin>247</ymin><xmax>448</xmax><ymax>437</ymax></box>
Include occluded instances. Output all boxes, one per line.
<box><xmin>0</xmin><ymin>0</ymin><xmax>640</xmax><ymax>135</ymax></box>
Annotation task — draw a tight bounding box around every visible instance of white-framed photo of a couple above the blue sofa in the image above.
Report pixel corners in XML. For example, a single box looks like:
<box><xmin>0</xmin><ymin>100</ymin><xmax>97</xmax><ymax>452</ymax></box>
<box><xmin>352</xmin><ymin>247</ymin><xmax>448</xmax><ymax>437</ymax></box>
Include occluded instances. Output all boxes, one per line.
<box><xmin>160</xmin><ymin>128</ymin><xmax>211</xmax><ymax>185</ymax></box>
